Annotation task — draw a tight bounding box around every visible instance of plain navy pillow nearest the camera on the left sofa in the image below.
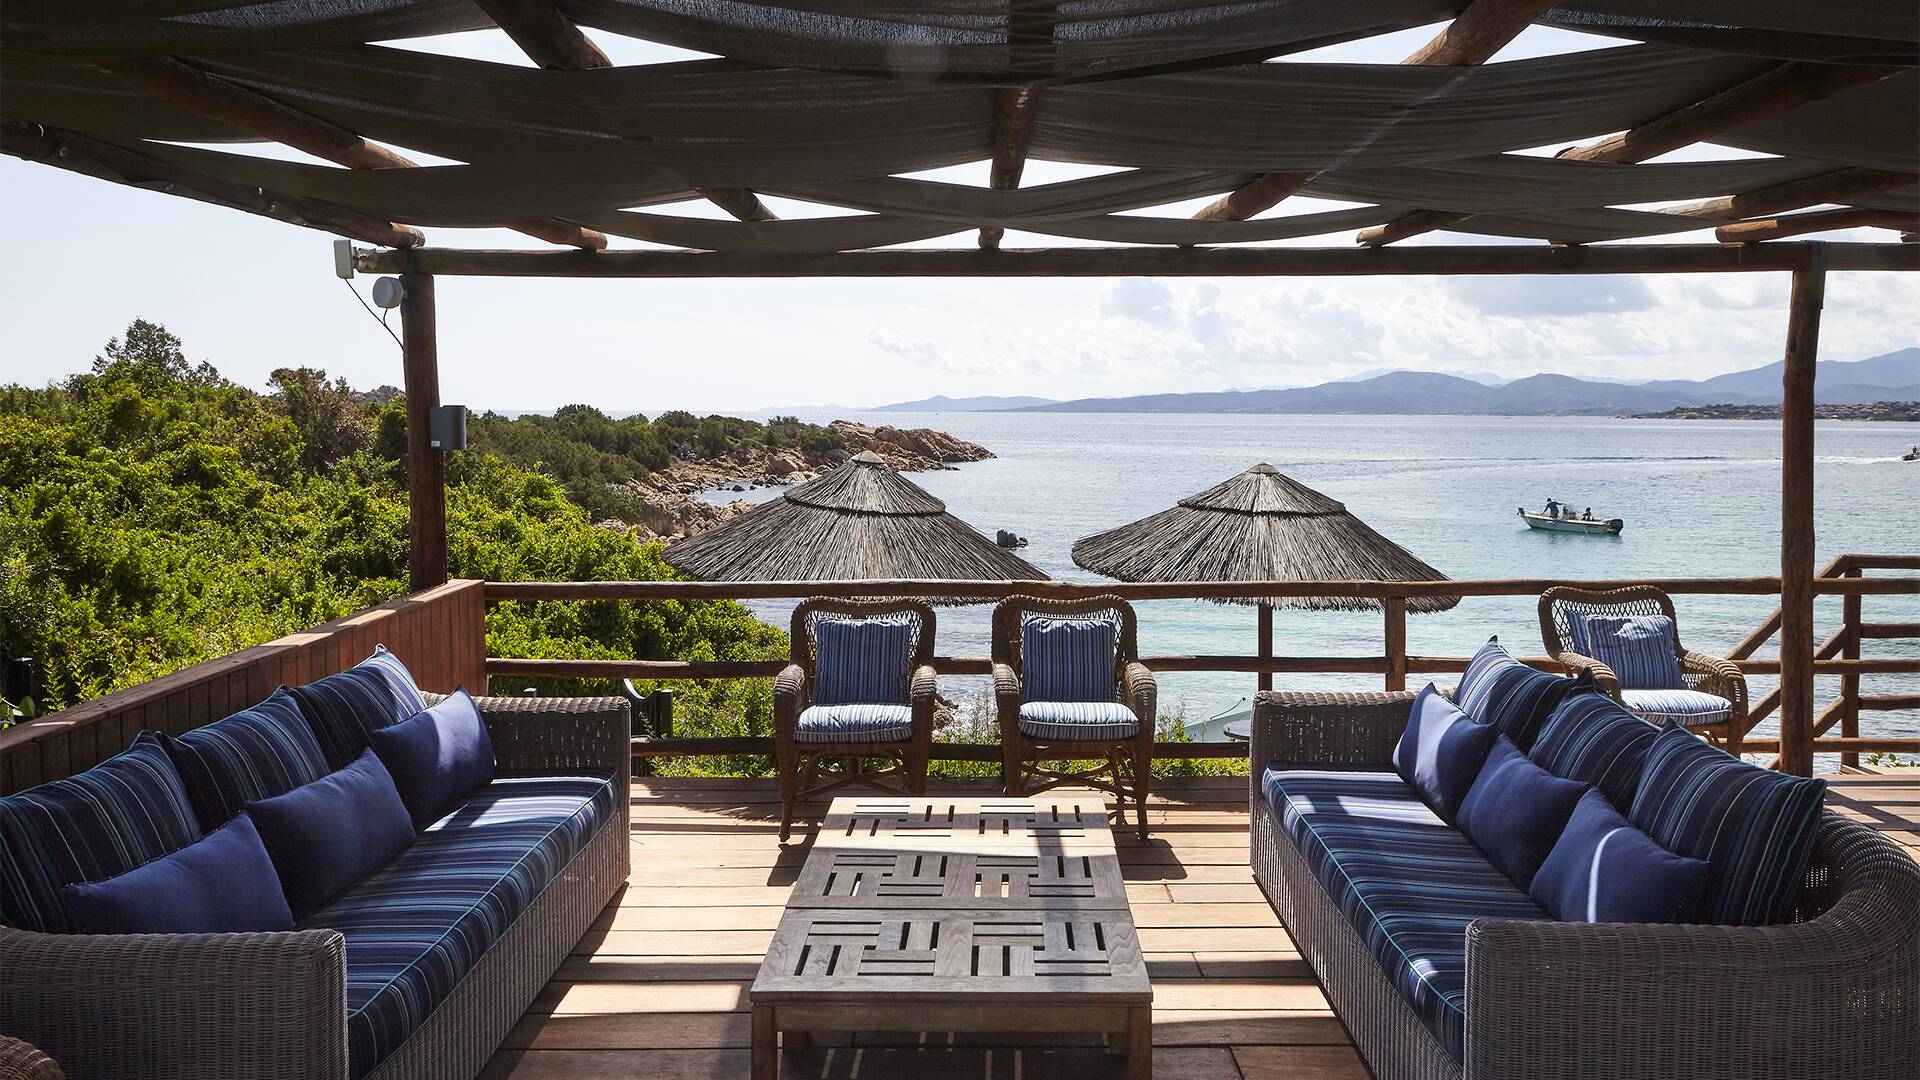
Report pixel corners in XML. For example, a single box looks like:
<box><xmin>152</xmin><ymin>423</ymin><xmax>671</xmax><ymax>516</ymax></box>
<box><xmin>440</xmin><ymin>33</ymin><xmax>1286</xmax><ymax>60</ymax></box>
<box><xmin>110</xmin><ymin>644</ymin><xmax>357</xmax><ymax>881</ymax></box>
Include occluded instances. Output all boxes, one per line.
<box><xmin>65</xmin><ymin>813</ymin><xmax>294</xmax><ymax>934</ymax></box>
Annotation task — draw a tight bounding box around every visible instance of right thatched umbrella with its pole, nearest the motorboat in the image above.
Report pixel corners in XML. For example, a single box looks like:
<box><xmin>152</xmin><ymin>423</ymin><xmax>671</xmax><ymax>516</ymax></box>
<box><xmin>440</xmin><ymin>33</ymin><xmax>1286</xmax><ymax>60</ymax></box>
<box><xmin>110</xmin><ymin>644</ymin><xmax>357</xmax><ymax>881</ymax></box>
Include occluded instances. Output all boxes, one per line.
<box><xmin>1073</xmin><ymin>465</ymin><xmax>1459</xmax><ymax>690</ymax></box>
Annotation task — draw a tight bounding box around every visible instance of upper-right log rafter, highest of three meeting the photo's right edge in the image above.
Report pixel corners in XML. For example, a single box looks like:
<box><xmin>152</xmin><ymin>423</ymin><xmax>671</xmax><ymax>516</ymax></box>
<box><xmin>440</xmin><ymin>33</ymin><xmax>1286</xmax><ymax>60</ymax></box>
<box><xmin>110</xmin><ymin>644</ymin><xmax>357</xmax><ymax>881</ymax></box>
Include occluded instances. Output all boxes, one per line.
<box><xmin>1356</xmin><ymin>63</ymin><xmax>1905</xmax><ymax>248</ymax></box>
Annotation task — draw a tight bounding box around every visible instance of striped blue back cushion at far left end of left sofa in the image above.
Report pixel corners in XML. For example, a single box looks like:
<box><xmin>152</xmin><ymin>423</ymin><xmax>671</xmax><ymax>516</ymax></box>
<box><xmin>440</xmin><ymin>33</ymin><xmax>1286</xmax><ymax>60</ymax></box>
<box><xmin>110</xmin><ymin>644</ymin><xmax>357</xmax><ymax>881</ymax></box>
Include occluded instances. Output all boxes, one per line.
<box><xmin>0</xmin><ymin>732</ymin><xmax>200</xmax><ymax>934</ymax></box>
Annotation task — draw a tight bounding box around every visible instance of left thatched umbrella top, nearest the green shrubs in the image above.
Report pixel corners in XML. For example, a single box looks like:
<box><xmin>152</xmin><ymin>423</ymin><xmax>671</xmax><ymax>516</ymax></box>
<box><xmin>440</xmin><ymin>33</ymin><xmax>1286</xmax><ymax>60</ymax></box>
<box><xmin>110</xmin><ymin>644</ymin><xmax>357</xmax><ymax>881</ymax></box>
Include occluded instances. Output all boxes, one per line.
<box><xmin>666</xmin><ymin>452</ymin><xmax>1046</xmax><ymax>580</ymax></box>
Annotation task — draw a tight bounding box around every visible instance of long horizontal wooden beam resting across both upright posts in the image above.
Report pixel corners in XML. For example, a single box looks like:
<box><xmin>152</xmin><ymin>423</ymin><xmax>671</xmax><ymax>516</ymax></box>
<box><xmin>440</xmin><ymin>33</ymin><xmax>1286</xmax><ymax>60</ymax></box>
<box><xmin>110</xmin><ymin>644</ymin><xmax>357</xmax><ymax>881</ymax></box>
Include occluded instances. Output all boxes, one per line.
<box><xmin>357</xmin><ymin>242</ymin><xmax>1920</xmax><ymax>279</ymax></box>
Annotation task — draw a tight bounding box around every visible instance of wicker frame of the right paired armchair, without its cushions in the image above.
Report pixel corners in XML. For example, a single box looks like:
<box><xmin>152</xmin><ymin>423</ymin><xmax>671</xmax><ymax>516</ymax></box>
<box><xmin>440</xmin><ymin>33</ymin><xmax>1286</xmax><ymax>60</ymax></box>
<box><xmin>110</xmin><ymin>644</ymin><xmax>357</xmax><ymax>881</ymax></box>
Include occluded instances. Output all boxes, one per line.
<box><xmin>993</xmin><ymin>596</ymin><xmax>1158</xmax><ymax>840</ymax></box>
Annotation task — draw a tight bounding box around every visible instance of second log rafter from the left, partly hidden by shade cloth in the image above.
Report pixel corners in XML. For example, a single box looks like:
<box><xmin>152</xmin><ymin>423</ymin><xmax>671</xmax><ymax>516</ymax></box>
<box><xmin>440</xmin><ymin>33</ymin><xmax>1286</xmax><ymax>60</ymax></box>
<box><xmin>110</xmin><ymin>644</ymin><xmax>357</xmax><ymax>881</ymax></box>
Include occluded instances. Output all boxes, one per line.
<box><xmin>94</xmin><ymin>56</ymin><xmax>607</xmax><ymax>250</ymax></box>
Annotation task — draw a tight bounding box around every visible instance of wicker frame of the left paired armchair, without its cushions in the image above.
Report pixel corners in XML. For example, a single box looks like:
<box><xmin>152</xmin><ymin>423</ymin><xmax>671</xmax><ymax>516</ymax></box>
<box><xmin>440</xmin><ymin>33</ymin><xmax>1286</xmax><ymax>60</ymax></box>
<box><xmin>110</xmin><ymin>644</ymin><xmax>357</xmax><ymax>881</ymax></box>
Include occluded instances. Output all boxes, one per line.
<box><xmin>774</xmin><ymin>598</ymin><xmax>935</xmax><ymax>840</ymax></box>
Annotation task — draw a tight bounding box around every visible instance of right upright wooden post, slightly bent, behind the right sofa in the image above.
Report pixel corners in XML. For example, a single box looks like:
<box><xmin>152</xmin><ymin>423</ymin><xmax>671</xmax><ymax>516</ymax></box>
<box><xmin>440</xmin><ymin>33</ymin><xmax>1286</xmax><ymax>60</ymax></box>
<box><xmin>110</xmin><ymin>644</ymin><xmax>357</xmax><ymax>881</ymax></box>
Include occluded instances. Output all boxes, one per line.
<box><xmin>1780</xmin><ymin>244</ymin><xmax>1826</xmax><ymax>776</ymax></box>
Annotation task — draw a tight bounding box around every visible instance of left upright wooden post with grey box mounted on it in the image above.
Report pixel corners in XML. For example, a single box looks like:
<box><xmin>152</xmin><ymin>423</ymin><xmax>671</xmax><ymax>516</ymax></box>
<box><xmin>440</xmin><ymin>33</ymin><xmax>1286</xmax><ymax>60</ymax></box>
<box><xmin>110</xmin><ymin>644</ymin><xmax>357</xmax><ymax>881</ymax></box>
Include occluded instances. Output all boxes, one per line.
<box><xmin>399</xmin><ymin>271</ymin><xmax>447</xmax><ymax>592</ymax></box>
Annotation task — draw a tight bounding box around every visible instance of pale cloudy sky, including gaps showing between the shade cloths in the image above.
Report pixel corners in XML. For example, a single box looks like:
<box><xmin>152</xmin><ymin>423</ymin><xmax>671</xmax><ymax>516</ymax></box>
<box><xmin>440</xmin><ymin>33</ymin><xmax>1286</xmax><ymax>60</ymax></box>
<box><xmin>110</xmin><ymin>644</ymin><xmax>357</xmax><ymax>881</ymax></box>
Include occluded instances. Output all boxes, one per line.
<box><xmin>0</xmin><ymin>27</ymin><xmax>1920</xmax><ymax>413</ymax></box>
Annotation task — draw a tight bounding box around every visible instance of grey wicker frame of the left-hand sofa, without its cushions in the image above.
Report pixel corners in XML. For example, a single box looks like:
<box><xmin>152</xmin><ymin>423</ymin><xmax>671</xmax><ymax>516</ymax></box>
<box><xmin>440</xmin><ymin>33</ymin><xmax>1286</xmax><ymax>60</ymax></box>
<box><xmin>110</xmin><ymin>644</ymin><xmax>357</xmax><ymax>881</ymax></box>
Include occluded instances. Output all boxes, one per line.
<box><xmin>0</xmin><ymin>696</ymin><xmax>632</xmax><ymax>1080</ymax></box>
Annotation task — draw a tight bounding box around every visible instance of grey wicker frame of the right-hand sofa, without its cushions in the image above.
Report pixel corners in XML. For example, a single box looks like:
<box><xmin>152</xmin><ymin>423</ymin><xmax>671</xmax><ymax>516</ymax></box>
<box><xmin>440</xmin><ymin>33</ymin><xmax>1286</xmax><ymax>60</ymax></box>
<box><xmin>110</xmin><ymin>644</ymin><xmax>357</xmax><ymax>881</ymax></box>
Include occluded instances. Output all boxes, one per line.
<box><xmin>1250</xmin><ymin>692</ymin><xmax>1920</xmax><ymax>1080</ymax></box>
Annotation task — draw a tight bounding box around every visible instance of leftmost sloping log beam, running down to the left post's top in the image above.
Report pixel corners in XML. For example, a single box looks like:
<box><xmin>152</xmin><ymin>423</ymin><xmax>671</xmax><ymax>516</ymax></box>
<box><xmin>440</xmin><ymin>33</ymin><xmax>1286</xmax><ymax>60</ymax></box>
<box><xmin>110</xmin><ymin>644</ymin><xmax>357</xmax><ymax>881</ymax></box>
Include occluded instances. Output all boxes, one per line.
<box><xmin>0</xmin><ymin>119</ymin><xmax>426</xmax><ymax>248</ymax></box>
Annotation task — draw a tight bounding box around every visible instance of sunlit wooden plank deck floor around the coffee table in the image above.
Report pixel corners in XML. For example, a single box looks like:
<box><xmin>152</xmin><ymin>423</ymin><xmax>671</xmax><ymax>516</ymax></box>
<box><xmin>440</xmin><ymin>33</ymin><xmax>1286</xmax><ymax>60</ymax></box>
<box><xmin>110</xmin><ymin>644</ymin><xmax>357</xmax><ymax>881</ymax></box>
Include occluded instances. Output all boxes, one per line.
<box><xmin>484</xmin><ymin>776</ymin><xmax>1920</xmax><ymax>1080</ymax></box>
